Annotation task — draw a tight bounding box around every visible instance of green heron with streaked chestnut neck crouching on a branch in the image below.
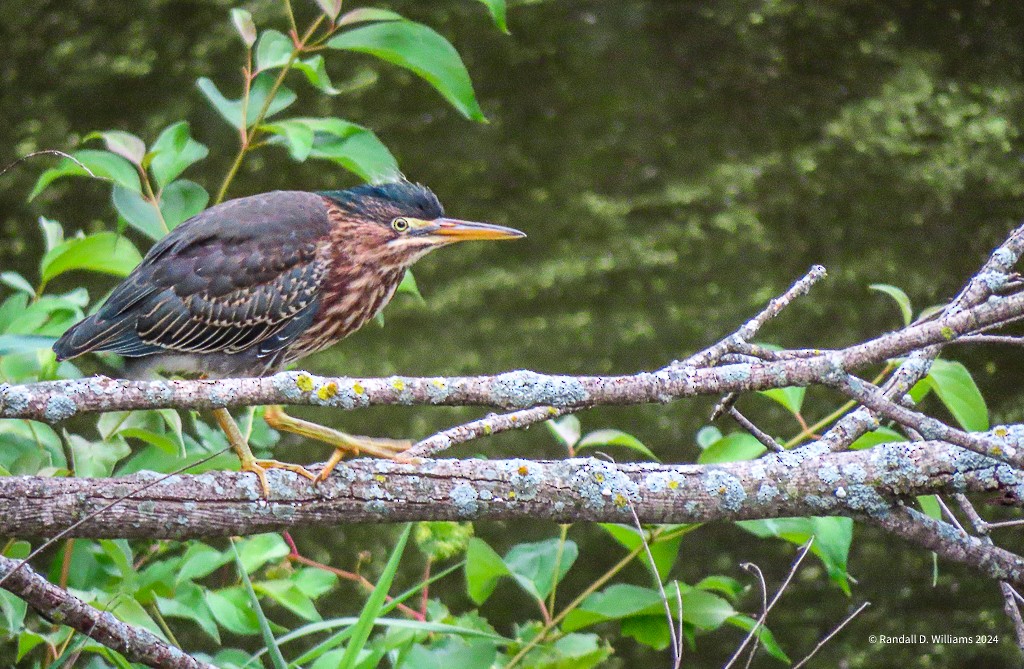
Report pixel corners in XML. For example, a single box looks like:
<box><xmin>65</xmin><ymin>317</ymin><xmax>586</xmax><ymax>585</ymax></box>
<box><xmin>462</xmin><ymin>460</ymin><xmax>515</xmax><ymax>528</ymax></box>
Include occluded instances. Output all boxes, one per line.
<box><xmin>53</xmin><ymin>180</ymin><xmax>524</xmax><ymax>495</ymax></box>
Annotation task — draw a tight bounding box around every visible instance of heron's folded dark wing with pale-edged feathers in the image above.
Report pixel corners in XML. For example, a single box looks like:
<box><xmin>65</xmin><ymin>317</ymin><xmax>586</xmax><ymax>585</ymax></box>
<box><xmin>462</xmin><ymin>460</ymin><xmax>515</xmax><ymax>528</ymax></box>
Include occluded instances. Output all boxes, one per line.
<box><xmin>54</xmin><ymin>192</ymin><xmax>331</xmax><ymax>359</ymax></box>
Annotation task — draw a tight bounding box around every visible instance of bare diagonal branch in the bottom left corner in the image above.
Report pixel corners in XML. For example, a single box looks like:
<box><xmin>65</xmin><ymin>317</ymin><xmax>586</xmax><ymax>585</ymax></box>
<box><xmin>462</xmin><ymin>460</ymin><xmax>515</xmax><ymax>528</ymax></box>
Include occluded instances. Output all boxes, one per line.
<box><xmin>0</xmin><ymin>555</ymin><xmax>215</xmax><ymax>669</ymax></box>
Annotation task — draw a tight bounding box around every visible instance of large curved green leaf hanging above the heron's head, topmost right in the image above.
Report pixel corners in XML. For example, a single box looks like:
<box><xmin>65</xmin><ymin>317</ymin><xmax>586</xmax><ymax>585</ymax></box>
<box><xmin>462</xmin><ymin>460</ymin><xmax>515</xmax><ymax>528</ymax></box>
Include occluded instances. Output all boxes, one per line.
<box><xmin>327</xmin><ymin>20</ymin><xmax>486</xmax><ymax>121</ymax></box>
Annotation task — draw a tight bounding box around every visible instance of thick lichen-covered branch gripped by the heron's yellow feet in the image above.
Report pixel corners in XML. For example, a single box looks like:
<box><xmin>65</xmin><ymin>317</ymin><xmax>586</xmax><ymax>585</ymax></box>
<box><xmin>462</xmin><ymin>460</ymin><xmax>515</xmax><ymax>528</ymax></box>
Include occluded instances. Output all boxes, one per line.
<box><xmin>0</xmin><ymin>442</ymin><xmax>1024</xmax><ymax>585</ymax></box>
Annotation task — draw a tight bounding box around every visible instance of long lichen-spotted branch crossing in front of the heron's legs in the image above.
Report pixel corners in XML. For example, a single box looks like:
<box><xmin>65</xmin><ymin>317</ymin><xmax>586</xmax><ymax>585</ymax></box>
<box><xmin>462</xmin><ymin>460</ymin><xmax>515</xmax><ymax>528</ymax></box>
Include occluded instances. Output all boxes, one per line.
<box><xmin>6</xmin><ymin>284</ymin><xmax>1024</xmax><ymax>423</ymax></box>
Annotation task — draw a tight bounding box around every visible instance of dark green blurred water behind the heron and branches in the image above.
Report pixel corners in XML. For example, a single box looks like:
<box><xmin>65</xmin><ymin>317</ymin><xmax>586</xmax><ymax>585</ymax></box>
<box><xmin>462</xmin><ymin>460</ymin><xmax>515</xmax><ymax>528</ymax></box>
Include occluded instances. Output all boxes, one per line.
<box><xmin>0</xmin><ymin>0</ymin><xmax>1024</xmax><ymax>667</ymax></box>
